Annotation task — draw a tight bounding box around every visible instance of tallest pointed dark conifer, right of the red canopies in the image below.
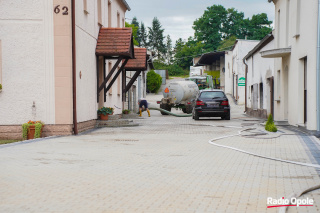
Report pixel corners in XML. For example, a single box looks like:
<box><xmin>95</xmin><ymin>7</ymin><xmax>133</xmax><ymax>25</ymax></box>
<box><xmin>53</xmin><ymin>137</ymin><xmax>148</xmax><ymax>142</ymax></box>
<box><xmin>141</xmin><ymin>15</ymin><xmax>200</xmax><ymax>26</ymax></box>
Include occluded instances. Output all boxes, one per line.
<box><xmin>148</xmin><ymin>17</ymin><xmax>166</xmax><ymax>59</ymax></box>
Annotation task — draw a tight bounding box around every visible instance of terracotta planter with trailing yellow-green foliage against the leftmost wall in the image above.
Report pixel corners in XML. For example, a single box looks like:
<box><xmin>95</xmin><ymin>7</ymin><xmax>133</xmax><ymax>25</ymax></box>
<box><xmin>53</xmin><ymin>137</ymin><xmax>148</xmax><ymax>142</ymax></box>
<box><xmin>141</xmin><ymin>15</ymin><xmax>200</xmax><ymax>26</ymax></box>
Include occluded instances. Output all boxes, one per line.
<box><xmin>22</xmin><ymin>120</ymin><xmax>44</xmax><ymax>140</ymax></box>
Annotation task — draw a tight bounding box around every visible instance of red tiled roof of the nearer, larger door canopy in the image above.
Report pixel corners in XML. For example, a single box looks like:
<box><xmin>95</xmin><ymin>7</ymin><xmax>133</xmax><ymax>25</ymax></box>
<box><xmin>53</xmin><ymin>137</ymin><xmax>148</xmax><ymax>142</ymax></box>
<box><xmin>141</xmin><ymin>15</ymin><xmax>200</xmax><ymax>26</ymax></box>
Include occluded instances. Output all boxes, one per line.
<box><xmin>96</xmin><ymin>28</ymin><xmax>134</xmax><ymax>58</ymax></box>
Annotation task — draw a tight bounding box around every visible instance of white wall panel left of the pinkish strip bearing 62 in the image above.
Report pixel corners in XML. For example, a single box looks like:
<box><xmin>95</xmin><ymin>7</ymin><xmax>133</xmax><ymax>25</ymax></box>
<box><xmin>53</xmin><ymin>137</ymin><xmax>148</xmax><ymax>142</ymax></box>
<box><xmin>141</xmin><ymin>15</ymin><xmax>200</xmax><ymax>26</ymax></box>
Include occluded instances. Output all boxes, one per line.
<box><xmin>0</xmin><ymin>0</ymin><xmax>55</xmax><ymax>125</ymax></box>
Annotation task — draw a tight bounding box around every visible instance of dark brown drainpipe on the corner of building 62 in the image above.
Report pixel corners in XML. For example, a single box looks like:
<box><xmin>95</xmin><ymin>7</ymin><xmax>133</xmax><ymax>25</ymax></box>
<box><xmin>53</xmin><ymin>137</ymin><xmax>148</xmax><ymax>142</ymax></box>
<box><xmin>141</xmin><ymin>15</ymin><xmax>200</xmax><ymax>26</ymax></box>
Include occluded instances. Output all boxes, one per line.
<box><xmin>71</xmin><ymin>0</ymin><xmax>78</xmax><ymax>135</ymax></box>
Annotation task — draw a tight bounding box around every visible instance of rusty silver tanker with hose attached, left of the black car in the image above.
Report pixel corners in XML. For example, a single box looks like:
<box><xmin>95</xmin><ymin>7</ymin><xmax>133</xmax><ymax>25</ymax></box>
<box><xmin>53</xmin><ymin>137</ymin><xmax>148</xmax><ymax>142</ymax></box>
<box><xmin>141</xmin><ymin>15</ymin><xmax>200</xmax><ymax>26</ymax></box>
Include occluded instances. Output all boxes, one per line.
<box><xmin>160</xmin><ymin>81</ymin><xmax>199</xmax><ymax>115</ymax></box>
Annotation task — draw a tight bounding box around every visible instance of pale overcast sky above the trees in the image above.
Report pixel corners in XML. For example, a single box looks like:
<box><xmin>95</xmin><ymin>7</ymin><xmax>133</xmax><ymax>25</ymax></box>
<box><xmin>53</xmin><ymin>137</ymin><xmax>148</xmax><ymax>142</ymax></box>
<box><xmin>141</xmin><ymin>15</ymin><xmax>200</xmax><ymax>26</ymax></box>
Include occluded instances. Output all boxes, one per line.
<box><xmin>126</xmin><ymin>0</ymin><xmax>274</xmax><ymax>45</ymax></box>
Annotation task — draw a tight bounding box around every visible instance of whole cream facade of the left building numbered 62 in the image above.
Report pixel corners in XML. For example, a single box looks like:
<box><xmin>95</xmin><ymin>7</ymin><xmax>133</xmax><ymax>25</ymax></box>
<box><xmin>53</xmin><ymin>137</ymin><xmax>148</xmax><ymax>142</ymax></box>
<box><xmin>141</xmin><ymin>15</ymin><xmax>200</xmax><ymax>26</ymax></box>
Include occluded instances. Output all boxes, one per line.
<box><xmin>0</xmin><ymin>0</ymin><xmax>130</xmax><ymax>138</ymax></box>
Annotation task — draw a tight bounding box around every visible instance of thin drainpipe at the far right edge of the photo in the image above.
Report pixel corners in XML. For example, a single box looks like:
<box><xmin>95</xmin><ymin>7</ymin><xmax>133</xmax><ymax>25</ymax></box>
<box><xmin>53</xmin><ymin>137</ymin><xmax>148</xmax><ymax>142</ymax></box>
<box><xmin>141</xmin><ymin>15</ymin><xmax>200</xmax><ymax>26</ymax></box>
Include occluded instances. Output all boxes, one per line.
<box><xmin>317</xmin><ymin>0</ymin><xmax>320</xmax><ymax>131</ymax></box>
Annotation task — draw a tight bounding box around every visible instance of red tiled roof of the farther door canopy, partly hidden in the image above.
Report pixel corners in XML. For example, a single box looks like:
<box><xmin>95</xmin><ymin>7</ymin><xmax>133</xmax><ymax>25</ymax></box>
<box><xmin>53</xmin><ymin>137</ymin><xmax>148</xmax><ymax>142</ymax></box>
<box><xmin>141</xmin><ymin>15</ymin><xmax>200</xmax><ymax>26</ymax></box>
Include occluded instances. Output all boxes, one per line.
<box><xmin>124</xmin><ymin>48</ymin><xmax>147</xmax><ymax>71</ymax></box>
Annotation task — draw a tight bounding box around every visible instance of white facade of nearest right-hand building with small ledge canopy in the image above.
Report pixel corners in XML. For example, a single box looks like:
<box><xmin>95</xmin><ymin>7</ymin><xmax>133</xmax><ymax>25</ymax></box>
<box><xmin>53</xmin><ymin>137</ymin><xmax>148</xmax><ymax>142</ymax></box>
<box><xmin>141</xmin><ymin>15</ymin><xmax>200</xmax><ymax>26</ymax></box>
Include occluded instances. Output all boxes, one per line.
<box><xmin>262</xmin><ymin>0</ymin><xmax>319</xmax><ymax>130</ymax></box>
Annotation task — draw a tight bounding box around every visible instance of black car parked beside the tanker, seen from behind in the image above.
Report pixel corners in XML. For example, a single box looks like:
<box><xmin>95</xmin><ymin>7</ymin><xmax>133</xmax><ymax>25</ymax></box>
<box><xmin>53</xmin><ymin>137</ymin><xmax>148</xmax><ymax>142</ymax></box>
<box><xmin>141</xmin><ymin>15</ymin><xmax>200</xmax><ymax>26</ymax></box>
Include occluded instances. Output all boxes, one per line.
<box><xmin>192</xmin><ymin>89</ymin><xmax>230</xmax><ymax>120</ymax></box>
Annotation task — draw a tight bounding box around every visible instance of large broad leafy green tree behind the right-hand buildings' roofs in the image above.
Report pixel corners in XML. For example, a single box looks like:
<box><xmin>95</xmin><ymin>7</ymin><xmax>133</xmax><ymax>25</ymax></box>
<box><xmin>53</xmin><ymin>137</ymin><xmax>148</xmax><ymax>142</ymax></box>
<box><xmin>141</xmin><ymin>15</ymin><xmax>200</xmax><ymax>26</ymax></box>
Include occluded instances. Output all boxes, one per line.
<box><xmin>193</xmin><ymin>5</ymin><xmax>272</xmax><ymax>52</ymax></box>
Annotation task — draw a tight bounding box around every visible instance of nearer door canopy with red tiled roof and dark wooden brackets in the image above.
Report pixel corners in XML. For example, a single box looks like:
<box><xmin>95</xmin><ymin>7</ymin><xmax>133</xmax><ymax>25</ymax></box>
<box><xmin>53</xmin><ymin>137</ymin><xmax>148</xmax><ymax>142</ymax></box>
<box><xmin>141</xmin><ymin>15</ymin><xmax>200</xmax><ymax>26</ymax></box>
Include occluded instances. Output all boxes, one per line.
<box><xmin>96</xmin><ymin>28</ymin><xmax>134</xmax><ymax>102</ymax></box>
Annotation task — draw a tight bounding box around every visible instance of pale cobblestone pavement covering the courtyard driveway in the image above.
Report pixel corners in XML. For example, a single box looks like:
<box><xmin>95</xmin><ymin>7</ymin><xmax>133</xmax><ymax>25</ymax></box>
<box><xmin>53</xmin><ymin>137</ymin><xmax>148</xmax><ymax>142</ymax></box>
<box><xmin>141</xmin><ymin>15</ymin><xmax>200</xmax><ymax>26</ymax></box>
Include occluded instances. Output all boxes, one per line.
<box><xmin>0</xmin><ymin>95</ymin><xmax>320</xmax><ymax>213</ymax></box>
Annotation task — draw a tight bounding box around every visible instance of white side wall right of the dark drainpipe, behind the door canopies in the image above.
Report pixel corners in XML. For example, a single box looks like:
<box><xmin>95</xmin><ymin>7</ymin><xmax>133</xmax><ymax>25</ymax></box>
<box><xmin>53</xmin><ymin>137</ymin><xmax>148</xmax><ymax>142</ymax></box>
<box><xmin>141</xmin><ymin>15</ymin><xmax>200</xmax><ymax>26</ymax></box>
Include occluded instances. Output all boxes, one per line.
<box><xmin>76</xmin><ymin>0</ymin><xmax>126</xmax><ymax>122</ymax></box>
